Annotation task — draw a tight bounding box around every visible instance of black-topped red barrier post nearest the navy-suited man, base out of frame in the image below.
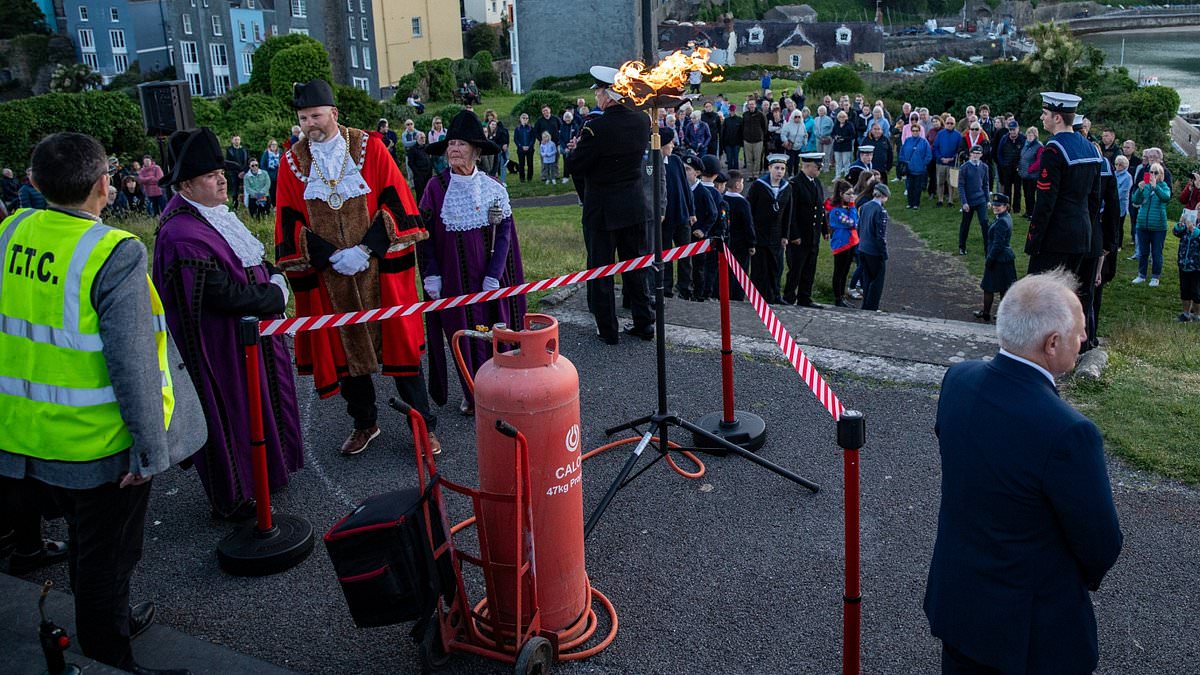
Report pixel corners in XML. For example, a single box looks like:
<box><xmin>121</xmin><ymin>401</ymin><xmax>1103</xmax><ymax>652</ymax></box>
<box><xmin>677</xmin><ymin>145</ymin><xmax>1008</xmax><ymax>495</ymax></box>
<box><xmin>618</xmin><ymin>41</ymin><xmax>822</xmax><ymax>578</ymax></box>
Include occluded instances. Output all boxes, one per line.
<box><xmin>838</xmin><ymin>410</ymin><xmax>866</xmax><ymax>675</ymax></box>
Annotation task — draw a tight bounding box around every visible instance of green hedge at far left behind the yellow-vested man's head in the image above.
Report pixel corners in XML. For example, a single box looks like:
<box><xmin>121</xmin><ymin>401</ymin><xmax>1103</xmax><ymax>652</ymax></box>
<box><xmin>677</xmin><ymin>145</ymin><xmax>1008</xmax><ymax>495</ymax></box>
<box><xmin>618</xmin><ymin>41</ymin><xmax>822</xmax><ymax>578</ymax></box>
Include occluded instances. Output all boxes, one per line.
<box><xmin>0</xmin><ymin>91</ymin><xmax>150</xmax><ymax>173</ymax></box>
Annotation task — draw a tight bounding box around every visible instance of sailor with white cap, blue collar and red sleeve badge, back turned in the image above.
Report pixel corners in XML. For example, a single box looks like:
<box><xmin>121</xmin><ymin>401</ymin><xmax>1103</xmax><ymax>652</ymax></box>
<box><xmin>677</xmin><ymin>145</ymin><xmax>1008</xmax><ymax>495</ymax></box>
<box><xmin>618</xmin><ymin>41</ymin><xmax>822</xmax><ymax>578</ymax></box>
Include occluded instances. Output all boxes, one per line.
<box><xmin>1025</xmin><ymin>91</ymin><xmax>1103</xmax><ymax>276</ymax></box>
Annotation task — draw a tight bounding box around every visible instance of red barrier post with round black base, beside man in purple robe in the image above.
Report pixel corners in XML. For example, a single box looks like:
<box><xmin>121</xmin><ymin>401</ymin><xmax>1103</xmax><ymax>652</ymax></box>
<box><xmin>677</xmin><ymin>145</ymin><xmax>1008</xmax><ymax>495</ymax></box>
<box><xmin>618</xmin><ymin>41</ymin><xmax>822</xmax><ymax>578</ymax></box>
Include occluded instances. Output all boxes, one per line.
<box><xmin>217</xmin><ymin>316</ymin><xmax>313</xmax><ymax>577</ymax></box>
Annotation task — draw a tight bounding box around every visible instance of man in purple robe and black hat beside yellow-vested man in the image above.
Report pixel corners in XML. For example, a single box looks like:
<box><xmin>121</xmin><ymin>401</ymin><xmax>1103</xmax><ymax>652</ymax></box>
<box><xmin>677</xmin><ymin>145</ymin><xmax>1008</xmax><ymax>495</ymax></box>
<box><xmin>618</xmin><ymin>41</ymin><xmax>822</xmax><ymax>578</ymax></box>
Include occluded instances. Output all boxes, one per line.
<box><xmin>154</xmin><ymin>127</ymin><xmax>304</xmax><ymax>520</ymax></box>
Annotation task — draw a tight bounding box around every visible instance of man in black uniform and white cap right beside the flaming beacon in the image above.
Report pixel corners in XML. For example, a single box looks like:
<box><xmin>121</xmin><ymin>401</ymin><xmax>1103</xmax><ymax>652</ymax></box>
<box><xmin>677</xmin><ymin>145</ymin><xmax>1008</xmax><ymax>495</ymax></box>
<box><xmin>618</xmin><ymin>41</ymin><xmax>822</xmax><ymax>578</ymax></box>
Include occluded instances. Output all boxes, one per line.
<box><xmin>566</xmin><ymin>66</ymin><xmax>654</xmax><ymax>345</ymax></box>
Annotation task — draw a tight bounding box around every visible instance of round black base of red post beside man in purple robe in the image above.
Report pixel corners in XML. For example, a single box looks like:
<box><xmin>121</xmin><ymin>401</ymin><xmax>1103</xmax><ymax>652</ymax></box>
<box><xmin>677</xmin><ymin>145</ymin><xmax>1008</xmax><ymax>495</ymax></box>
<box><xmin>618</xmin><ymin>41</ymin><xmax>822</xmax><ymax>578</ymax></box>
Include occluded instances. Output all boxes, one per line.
<box><xmin>217</xmin><ymin>514</ymin><xmax>313</xmax><ymax>577</ymax></box>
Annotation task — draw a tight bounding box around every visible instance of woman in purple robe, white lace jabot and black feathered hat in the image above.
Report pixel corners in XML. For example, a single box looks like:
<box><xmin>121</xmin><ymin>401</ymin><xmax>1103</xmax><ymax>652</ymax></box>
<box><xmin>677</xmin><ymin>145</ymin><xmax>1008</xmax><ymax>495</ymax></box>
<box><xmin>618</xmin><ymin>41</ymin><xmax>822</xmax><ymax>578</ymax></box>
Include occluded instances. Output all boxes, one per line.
<box><xmin>418</xmin><ymin>110</ymin><xmax>526</xmax><ymax>414</ymax></box>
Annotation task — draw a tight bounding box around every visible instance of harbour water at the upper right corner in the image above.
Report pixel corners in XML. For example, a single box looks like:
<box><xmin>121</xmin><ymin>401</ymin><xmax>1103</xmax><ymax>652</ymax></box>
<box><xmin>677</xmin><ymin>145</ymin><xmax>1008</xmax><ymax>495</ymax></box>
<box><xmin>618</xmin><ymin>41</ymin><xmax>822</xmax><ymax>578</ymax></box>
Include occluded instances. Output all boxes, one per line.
<box><xmin>1082</xmin><ymin>29</ymin><xmax>1200</xmax><ymax>110</ymax></box>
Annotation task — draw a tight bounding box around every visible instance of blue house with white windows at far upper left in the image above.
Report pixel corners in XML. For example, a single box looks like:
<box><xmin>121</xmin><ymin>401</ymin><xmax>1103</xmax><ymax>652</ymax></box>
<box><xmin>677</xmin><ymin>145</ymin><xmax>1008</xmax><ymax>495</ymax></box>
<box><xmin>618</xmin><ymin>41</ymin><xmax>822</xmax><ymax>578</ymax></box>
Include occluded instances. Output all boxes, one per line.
<box><xmin>62</xmin><ymin>0</ymin><xmax>172</xmax><ymax>83</ymax></box>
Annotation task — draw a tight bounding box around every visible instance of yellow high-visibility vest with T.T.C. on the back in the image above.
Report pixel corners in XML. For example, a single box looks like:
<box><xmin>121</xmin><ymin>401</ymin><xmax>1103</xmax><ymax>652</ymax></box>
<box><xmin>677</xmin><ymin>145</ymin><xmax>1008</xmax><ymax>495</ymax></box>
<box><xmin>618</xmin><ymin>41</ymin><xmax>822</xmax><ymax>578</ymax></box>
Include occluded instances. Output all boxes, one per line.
<box><xmin>0</xmin><ymin>209</ymin><xmax>175</xmax><ymax>461</ymax></box>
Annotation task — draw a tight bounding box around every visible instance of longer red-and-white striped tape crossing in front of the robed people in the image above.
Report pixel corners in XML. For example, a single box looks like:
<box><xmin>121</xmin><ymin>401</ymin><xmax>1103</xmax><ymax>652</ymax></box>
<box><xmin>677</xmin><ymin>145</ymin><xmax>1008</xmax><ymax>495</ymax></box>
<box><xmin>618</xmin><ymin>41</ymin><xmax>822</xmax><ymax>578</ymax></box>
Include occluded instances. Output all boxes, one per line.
<box><xmin>258</xmin><ymin>239</ymin><xmax>712</xmax><ymax>335</ymax></box>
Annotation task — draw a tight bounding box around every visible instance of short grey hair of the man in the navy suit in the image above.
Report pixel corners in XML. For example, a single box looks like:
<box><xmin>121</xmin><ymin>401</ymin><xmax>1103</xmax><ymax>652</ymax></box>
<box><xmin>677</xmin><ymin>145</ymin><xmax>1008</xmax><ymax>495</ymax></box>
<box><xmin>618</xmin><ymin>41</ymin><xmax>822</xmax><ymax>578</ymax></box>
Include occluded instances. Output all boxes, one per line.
<box><xmin>996</xmin><ymin>268</ymin><xmax>1079</xmax><ymax>354</ymax></box>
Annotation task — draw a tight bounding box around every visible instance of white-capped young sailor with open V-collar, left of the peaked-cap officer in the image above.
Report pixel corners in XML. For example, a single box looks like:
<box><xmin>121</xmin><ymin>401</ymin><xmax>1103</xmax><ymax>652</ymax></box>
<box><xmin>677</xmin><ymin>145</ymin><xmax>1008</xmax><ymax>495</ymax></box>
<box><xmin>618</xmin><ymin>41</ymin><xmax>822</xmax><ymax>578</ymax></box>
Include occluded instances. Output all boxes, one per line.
<box><xmin>746</xmin><ymin>155</ymin><xmax>792</xmax><ymax>304</ymax></box>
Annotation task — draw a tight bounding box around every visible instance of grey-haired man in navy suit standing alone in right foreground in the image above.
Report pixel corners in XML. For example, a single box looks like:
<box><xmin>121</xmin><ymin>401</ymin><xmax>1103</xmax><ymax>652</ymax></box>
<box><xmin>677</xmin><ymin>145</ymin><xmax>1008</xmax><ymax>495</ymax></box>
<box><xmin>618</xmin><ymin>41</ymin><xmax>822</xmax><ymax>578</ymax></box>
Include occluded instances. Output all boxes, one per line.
<box><xmin>924</xmin><ymin>270</ymin><xmax>1122</xmax><ymax>675</ymax></box>
